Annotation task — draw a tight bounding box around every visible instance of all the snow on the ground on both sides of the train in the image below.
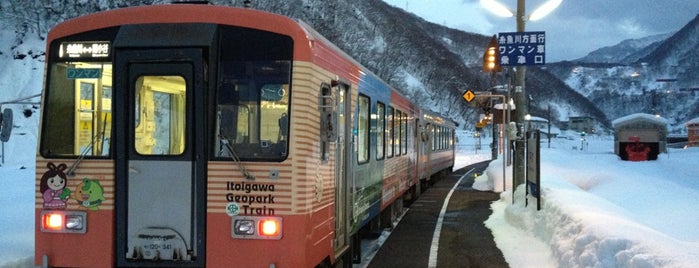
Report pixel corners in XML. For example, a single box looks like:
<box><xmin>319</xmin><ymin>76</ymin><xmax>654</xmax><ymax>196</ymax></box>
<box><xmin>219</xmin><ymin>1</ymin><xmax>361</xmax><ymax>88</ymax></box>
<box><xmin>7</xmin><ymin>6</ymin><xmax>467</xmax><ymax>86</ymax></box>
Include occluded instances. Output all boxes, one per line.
<box><xmin>0</xmin><ymin>31</ymin><xmax>699</xmax><ymax>267</ymax></box>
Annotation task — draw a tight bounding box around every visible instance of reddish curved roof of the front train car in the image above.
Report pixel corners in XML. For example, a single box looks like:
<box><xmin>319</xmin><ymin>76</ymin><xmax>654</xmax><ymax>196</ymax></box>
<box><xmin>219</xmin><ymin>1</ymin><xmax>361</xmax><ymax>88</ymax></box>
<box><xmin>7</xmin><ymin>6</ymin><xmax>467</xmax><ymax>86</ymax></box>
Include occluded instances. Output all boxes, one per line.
<box><xmin>47</xmin><ymin>4</ymin><xmax>400</xmax><ymax>87</ymax></box>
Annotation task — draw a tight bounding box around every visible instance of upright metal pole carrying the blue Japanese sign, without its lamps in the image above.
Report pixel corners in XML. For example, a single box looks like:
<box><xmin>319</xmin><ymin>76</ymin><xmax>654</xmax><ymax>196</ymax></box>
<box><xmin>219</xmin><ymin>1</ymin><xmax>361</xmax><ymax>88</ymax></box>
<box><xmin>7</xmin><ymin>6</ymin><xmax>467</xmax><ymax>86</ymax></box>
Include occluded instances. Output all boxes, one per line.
<box><xmin>512</xmin><ymin>0</ymin><xmax>529</xmax><ymax>188</ymax></box>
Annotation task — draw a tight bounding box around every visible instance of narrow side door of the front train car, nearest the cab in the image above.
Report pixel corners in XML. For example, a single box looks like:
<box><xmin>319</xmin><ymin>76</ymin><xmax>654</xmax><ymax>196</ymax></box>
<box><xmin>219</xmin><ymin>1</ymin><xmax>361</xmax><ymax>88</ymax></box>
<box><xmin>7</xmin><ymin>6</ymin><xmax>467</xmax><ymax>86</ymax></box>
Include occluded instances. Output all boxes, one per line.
<box><xmin>332</xmin><ymin>83</ymin><xmax>352</xmax><ymax>260</ymax></box>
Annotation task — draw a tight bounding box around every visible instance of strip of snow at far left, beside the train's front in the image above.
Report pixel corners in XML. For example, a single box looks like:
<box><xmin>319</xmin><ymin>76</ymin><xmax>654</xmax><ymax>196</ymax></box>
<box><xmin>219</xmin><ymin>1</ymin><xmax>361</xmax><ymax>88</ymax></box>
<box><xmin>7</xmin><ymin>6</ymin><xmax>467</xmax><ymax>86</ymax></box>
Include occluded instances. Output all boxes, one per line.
<box><xmin>0</xmin><ymin>30</ymin><xmax>46</xmax><ymax>267</ymax></box>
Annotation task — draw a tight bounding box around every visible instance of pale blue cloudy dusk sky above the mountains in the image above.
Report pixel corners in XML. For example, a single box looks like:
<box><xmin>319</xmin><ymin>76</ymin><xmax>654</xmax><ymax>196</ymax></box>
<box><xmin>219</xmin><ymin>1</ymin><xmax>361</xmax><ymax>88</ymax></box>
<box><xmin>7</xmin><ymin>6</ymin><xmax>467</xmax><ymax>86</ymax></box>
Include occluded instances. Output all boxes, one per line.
<box><xmin>384</xmin><ymin>0</ymin><xmax>699</xmax><ymax>62</ymax></box>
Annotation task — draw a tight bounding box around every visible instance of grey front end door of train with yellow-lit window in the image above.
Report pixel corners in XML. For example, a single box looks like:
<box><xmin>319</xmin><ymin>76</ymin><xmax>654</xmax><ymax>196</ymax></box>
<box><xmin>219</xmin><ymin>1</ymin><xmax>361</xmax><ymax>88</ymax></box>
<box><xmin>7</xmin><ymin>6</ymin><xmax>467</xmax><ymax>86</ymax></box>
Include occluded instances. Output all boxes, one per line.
<box><xmin>114</xmin><ymin>49</ymin><xmax>206</xmax><ymax>266</ymax></box>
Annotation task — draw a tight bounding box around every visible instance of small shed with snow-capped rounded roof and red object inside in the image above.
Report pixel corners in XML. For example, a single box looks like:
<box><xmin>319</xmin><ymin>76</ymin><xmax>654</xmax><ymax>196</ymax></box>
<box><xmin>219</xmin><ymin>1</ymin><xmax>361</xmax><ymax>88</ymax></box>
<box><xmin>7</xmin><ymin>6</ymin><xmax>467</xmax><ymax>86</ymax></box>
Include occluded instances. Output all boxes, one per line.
<box><xmin>612</xmin><ymin>113</ymin><xmax>668</xmax><ymax>161</ymax></box>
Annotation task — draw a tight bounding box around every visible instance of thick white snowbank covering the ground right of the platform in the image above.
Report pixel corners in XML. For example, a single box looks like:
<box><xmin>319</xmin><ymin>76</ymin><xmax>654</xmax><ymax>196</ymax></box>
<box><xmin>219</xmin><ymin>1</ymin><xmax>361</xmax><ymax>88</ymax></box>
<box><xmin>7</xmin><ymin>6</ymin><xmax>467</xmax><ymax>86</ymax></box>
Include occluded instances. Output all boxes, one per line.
<box><xmin>474</xmin><ymin>137</ymin><xmax>699</xmax><ymax>267</ymax></box>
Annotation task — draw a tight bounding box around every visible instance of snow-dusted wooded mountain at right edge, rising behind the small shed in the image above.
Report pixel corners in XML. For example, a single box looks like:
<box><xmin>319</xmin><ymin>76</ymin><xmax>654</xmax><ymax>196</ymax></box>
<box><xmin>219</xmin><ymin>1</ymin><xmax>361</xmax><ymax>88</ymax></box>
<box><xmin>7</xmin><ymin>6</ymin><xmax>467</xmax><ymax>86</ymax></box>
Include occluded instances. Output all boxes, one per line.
<box><xmin>546</xmin><ymin>16</ymin><xmax>699</xmax><ymax>133</ymax></box>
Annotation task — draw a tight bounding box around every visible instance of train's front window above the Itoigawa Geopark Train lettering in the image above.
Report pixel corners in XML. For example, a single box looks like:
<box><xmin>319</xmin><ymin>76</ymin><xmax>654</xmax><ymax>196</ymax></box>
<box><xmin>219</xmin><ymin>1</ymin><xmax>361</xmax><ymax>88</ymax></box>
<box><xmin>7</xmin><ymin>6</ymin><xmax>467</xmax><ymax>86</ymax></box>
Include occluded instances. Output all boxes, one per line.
<box><xmin>214</xmin><ymin>61</ymin><xmax>291</xmax><ymax>161</ymax></box>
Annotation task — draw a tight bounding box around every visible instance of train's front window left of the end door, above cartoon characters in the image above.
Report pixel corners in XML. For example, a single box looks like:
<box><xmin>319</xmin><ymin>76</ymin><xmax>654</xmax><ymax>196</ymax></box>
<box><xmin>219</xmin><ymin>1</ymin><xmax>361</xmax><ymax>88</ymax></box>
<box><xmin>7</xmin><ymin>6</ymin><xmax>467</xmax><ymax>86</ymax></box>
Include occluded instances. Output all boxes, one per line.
<box><xmin>40</xmin><ymin>61</ymin><xmax>112</xmax><ymax>157</ymax></box>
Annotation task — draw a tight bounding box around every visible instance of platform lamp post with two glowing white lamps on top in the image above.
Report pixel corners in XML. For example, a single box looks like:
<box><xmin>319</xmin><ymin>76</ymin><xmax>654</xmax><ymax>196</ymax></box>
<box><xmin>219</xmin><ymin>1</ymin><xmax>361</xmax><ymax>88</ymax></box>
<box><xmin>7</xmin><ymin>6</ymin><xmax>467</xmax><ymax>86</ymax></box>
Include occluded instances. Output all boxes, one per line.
<box><xmin>480</xmin><ymin>0</ymin><xmax>563</xmax><ymax>188</ymax></box>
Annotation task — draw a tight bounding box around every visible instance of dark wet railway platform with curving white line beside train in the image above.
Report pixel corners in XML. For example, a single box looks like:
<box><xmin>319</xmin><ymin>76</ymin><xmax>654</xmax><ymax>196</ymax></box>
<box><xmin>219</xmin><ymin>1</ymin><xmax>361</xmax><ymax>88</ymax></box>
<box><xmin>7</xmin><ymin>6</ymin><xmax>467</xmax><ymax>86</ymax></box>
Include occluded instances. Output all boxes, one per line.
<box><xmin>366</xmin><ymin>161</ymin><xmax>508</xmax><ymax>268</ymax></box>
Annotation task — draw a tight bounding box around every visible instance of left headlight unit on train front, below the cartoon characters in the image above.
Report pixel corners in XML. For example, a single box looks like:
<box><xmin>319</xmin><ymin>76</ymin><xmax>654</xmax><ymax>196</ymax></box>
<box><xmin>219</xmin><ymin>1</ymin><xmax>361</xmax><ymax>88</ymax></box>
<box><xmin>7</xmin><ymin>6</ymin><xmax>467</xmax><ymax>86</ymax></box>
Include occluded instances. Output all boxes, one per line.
<box><xmin>40</xmin><ymin>210</ymin><xmax>87</xmax><ymax>234</ymax></box>
